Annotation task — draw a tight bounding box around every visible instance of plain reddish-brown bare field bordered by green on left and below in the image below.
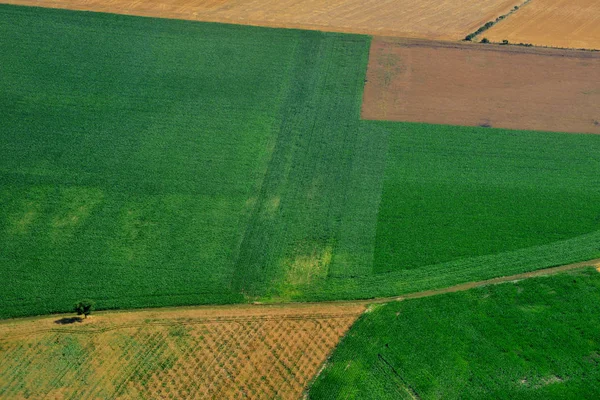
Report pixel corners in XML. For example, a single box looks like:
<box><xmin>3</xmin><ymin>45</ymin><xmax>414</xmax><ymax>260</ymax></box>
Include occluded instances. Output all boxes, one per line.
<box><xmin>362</xmin><ymin>38</ymin><xmax>600</xmax><ymax>134</ymax></box>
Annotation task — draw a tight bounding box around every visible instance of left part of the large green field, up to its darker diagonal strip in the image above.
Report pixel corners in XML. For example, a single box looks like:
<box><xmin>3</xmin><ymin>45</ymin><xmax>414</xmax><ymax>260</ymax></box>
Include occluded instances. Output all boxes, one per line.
<box><xmin>0</xmin><ymin>6</ymin><xmax>314</xmax><ymax>317</ymax></box>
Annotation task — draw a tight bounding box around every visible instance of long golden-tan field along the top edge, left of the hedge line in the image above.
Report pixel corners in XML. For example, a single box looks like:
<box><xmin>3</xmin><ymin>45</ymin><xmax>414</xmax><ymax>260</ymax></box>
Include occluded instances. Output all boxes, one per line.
<box><xmin>0</xmin><ymin>0</ymin><xmax>522</xmax><ymax>40</ymax></box>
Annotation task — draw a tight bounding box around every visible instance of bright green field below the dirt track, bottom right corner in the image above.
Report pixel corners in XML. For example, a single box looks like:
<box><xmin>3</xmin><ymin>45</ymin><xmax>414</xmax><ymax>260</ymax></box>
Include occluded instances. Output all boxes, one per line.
<box><xmin>309</xmin><ymin>268</ymin><xmax>600</xmax><ymax>399</ymax></box>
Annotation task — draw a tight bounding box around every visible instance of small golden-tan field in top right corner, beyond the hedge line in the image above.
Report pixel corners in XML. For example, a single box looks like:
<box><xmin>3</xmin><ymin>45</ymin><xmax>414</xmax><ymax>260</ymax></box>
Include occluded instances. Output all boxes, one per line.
<box><xmin>481</xmin><ymin>0</ymin><xmax>600</xmax><ymax>49</ymax></box>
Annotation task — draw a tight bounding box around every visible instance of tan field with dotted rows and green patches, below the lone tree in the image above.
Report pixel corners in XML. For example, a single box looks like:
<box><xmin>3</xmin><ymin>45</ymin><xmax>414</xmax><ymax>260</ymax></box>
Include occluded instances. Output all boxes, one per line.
<box><xmin>0</xmin><ymin>305</ymin><xmax>364</xmax><ymax>399</ymax></box>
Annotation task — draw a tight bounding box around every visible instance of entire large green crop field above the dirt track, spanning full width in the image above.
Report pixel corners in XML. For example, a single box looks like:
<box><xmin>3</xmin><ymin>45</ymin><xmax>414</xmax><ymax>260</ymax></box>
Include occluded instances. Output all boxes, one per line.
<box><xmin>0</xmin><ymin>5</ymin><xmax>600</xmax><ymax>318</ymax></box>
